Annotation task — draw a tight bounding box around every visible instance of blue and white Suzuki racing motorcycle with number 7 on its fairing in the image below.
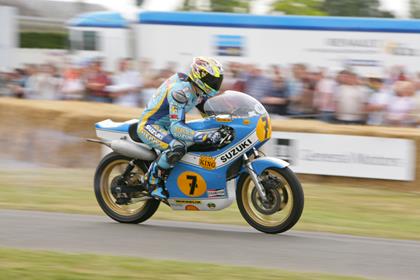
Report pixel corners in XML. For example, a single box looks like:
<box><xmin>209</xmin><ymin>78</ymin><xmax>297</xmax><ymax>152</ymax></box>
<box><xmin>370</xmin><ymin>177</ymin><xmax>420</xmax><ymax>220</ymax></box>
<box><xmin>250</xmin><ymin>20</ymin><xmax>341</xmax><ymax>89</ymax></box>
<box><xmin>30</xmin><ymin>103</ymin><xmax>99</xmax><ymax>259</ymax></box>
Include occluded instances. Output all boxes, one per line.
<box><xmin>88</xmin><ymin>91</ymin><xmax>304</xmax><ymax>234</ymax></box>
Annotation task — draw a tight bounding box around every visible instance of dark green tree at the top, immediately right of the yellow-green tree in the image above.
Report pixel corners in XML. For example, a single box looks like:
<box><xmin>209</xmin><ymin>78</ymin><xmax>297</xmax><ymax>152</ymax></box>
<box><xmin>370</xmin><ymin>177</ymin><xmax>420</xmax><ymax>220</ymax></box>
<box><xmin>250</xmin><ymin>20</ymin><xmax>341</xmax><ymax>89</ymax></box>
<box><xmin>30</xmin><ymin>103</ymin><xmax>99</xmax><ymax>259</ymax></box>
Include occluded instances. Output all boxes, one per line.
<box><xmin>322</xmin><ymin>0</ymin><xmax>395</xmax><ymax>17</ymax></box>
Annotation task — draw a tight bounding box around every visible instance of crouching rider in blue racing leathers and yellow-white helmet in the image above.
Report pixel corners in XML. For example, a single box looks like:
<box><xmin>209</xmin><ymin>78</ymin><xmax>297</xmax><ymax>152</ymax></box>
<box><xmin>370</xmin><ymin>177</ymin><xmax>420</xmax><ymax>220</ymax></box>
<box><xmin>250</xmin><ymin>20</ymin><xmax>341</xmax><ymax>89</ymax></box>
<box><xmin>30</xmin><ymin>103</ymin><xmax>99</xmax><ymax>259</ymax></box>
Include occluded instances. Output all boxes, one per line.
<box><xmin>137</xmin><ymin>57</ymin><xmax>223</xmax><ymax>199</ymax></box>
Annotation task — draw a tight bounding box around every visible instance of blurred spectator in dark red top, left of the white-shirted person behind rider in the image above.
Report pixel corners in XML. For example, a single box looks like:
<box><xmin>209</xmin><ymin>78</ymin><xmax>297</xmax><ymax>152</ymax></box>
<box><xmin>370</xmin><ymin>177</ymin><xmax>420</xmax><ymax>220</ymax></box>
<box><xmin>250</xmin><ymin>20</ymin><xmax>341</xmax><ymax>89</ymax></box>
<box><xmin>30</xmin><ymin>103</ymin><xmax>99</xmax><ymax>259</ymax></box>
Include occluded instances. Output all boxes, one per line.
<box><xmin>86</xmin><ymin>59</ymin><xmax>112</xmax><ymax>103</ymax></box>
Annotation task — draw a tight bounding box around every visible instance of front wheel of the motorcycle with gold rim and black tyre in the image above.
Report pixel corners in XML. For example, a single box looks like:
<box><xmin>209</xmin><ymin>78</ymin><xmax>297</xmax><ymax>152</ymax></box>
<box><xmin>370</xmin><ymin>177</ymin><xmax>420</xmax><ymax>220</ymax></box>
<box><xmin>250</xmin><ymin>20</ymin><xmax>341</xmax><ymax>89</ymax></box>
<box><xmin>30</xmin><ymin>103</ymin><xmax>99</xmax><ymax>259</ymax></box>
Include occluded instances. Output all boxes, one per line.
<box><xmin>236</xmin><ymin>168</ymin><xmax>304</xmax><ymax>234</ymax></box>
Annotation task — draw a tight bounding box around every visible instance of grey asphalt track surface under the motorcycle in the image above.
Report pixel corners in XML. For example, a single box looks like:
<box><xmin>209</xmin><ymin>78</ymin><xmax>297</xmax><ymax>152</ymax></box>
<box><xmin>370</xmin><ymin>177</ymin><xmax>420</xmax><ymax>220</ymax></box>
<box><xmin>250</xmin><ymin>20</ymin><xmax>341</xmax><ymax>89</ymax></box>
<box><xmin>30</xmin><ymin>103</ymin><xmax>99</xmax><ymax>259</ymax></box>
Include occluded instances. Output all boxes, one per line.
<box><xmin>0</xmin><ymin>210</ymin><xmax>420</xmax><ymax>279</ymax></box>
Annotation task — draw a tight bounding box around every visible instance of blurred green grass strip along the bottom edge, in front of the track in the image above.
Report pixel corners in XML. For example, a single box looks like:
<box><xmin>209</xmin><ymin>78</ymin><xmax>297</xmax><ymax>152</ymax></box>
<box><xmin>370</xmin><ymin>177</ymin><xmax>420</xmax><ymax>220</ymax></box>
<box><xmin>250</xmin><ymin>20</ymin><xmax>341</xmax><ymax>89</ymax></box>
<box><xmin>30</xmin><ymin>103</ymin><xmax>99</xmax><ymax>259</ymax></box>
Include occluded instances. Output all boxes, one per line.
<box><xmin>0</xmin><ymin>249</ymin><xmax>362</xmax><ymax>280</ymax></box>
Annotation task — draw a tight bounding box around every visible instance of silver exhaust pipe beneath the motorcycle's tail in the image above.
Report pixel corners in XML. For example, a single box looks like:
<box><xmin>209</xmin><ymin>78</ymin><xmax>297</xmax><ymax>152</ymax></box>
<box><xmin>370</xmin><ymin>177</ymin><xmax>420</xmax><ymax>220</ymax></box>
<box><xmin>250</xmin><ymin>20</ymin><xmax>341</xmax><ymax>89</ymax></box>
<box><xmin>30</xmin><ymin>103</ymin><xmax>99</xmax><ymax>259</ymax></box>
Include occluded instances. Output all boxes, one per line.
<box><xmin>87</xmin><ymin>139</ymin><xmax>157</xmax><ymax>161</ymax></box>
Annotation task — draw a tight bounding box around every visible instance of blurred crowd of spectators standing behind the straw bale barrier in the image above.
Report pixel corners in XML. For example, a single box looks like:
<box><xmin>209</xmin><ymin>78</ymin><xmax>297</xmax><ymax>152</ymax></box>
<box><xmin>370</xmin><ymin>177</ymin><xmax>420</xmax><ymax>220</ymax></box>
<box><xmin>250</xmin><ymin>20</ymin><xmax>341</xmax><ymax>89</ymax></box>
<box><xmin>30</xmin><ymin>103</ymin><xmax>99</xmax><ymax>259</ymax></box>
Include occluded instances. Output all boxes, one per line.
<box><xmin>0</xmin><ymin>58</ymin><xmax>420</xmax><ymax>127</ymax></box>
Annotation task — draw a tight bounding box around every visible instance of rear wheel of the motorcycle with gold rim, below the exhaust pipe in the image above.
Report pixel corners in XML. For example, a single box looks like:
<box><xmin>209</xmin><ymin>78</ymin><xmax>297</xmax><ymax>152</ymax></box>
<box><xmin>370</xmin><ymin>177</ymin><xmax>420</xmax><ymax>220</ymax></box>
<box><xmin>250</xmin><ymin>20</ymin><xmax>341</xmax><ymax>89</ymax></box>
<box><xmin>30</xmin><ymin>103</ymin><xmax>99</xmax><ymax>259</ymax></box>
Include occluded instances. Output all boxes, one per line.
<box><xmin>94</xmin><ymin>152</ymin><xmax>160</xmax><ymax>224</ymax></box>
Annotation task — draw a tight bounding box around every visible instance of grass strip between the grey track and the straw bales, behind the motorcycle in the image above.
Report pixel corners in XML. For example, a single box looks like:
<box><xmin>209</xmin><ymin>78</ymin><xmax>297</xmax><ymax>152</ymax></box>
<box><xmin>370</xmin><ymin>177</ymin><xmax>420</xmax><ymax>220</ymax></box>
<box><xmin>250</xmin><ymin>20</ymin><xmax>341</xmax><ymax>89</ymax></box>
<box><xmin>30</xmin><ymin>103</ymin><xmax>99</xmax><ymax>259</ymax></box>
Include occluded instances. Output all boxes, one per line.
<box><xmin>0</xmin><ymin>169</ymin><xmax>420</xmax><ymax>240</ymax></box>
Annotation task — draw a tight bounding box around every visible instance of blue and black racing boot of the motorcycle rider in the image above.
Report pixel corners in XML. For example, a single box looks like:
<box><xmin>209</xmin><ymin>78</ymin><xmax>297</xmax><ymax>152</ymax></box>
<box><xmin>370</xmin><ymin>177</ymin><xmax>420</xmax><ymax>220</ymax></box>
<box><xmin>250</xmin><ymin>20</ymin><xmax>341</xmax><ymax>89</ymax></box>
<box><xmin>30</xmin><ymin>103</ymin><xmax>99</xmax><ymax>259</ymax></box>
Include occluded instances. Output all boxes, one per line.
<box><xmin>146</xmin><ymin>162</ymin><xmax>169</xmax><ymax>200</ymax></box>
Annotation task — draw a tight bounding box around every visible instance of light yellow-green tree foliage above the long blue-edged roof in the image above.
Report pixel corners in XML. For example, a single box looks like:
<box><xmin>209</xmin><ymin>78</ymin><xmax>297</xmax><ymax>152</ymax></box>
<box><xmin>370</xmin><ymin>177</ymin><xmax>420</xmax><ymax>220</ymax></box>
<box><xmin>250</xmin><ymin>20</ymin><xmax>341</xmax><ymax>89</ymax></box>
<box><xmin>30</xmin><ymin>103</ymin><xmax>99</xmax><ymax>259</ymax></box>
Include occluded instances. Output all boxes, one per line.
<box><xmin>273</xmin><ymin>0</ymin><xmax>326</xmax><ymax>16</ymax></box>
